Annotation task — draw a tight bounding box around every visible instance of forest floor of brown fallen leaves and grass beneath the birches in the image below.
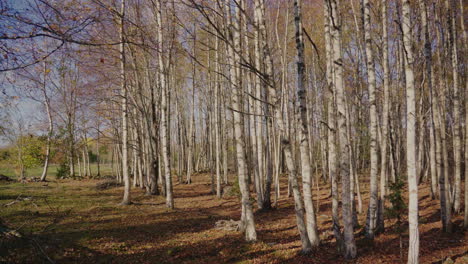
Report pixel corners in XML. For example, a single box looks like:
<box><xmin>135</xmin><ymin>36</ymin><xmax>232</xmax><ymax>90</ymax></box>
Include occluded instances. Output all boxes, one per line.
<box><xmin>0</xmin><ymin>174</ymin><xmax>468</xmax><ymax>264</ymax></box>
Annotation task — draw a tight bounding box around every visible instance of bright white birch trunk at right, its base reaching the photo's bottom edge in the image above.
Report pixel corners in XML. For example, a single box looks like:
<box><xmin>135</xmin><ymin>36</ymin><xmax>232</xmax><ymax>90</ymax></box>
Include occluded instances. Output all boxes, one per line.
<box><xmin>402</xmin><ymin>0</ymin><xmax>419</xmax><ymax>264</ymax></box>
